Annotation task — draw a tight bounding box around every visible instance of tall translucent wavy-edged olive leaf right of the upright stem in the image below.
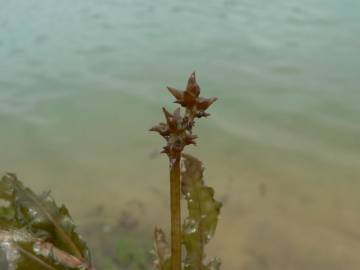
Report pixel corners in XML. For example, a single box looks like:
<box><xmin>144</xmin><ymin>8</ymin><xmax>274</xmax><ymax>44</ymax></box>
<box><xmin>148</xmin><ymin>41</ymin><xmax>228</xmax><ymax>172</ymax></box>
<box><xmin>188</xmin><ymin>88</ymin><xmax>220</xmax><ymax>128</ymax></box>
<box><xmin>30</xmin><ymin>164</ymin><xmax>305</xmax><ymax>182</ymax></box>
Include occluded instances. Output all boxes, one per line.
<box><xmin>181</xmin><ymin>154</ymin><xmax>222</xmax><ymax>270</ymax></box>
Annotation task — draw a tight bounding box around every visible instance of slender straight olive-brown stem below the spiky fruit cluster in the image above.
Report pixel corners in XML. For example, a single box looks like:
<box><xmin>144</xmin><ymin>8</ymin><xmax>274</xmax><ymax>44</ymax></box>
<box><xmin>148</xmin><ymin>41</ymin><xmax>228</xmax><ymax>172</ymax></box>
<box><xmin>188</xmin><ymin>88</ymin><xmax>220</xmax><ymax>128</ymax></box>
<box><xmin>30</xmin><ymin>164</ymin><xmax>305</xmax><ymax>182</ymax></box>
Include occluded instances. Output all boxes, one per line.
<box><xmin>170</xmin><ymin>156</ymin><xmax>182</xmax><ymax>270</ymax></box>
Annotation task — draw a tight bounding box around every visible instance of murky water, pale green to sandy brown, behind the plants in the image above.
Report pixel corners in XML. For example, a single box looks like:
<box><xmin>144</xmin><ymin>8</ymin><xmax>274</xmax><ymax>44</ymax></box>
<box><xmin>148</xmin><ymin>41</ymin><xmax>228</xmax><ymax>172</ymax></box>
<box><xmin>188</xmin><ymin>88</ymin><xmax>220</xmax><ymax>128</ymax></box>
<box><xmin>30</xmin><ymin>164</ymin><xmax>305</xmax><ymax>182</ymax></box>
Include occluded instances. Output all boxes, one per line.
<box><xmin>0</xmin><ymin>0</ymin><xmax>360</xmax><ymax>270</ymax></box>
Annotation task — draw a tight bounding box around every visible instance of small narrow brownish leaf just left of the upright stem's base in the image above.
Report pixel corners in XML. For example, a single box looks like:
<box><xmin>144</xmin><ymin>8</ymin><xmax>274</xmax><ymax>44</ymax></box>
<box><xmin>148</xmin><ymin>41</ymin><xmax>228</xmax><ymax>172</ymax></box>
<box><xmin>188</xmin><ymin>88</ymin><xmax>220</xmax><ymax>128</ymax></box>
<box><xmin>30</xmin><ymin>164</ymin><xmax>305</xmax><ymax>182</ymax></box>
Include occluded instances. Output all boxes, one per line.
<box><xmin>154</xmin><ymin>228</ymin><xmax>171</xmax><ymax>270</ymax></box>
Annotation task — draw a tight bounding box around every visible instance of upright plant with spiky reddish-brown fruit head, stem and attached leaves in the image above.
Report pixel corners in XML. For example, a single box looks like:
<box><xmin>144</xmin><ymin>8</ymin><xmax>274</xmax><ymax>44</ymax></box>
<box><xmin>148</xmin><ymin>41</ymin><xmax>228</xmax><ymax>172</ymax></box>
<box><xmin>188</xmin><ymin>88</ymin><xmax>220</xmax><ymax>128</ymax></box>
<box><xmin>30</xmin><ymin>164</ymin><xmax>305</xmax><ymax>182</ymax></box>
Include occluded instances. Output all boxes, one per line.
<box><xmin>150</xmin><ymin>73</ymin><xmax>221</xmax><ymax>270</ymax></box>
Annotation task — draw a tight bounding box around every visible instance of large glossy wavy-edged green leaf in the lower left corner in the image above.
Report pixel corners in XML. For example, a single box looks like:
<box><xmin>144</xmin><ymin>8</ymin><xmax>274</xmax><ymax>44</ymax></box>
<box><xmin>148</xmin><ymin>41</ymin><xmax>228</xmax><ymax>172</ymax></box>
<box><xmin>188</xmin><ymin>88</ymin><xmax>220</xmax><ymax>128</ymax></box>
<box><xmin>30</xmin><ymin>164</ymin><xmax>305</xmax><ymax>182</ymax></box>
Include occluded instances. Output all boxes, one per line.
<box><xmin>0</xmin><ymin>174</ymin><xmax>94</xmax><ymax>270</ymax></box>
